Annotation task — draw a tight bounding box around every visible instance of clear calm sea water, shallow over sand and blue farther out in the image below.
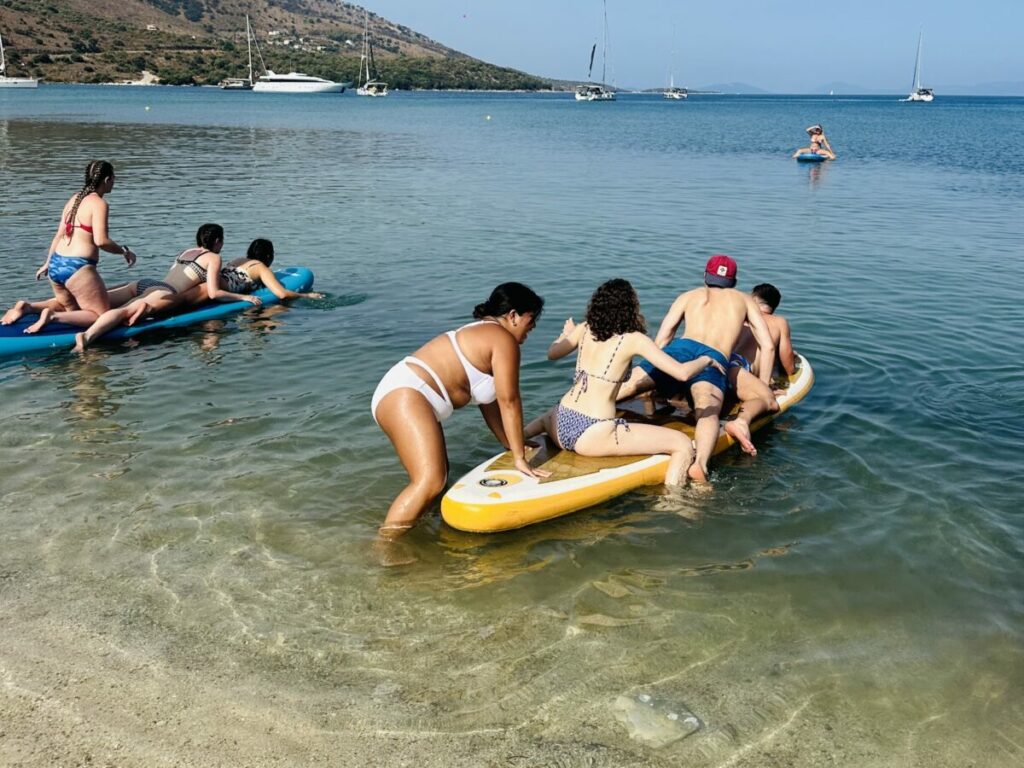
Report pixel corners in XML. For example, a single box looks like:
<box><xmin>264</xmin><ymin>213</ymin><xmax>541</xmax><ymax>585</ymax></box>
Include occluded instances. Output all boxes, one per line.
<box><xmin>0</xmin><ymin>86</ymin><xmax>1024</xmax><ymax>766</ymax></box>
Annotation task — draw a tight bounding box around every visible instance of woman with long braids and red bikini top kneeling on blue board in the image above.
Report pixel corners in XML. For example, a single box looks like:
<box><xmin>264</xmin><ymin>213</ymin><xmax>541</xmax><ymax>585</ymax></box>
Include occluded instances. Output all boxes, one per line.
<box><xmin>0</xmin><ymin>160</ymin><xmax>135</xmax><ymax>333</ymax></box>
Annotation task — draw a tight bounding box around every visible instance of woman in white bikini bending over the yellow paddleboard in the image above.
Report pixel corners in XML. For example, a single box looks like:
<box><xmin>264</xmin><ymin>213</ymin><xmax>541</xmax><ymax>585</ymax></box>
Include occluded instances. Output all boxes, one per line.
<box><xmin>370</xmin><ymin>283</ymin><xmax>548</xmax><ymax>539</ymax></box>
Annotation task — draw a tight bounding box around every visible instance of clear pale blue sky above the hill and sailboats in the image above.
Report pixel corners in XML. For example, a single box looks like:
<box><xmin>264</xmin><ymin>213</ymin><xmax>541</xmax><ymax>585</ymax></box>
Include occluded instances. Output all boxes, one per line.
<box><xmin>364</xmin><ymin>0</ymin><xmax>1024</xmax><ymax>93</ymax></box>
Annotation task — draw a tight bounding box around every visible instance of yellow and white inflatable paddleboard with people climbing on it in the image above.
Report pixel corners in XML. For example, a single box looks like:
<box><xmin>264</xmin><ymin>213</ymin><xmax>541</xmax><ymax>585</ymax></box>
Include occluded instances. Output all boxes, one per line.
<box><xmin>441</xmin><ymin>354</ymin><xmax>814</xmax><ymax>534</ymax></box>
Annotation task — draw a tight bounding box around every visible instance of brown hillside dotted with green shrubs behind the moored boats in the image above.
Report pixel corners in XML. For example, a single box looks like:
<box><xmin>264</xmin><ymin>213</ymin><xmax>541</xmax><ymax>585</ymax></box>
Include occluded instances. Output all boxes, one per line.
<box><xmin>0</xmin><ymin>0</ymin><xmax>550</xmax><ymax>90</ymax></box>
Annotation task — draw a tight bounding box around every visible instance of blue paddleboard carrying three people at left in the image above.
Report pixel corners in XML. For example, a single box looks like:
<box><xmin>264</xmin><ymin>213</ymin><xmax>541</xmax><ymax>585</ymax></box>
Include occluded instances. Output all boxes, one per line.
<box><xmin>0</xmin><ymin>266</ymin><xmax>313</xmax><ymax>357</ymax></box>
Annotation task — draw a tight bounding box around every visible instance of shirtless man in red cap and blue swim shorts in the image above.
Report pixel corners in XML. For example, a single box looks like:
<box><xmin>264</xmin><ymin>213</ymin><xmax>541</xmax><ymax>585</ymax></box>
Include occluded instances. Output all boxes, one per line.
<box><xmin>618</xmin><ymin>254</ymin><xmax>775</xmax><ymax>482</ymax></box>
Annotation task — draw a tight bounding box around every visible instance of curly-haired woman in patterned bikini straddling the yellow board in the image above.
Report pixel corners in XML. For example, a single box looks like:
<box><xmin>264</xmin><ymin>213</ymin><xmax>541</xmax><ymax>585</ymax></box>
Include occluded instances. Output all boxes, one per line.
<box><xmin>525</xmin><ymin>279</ymin><xmax>725</xmax><ymax>485</ymax></box>
